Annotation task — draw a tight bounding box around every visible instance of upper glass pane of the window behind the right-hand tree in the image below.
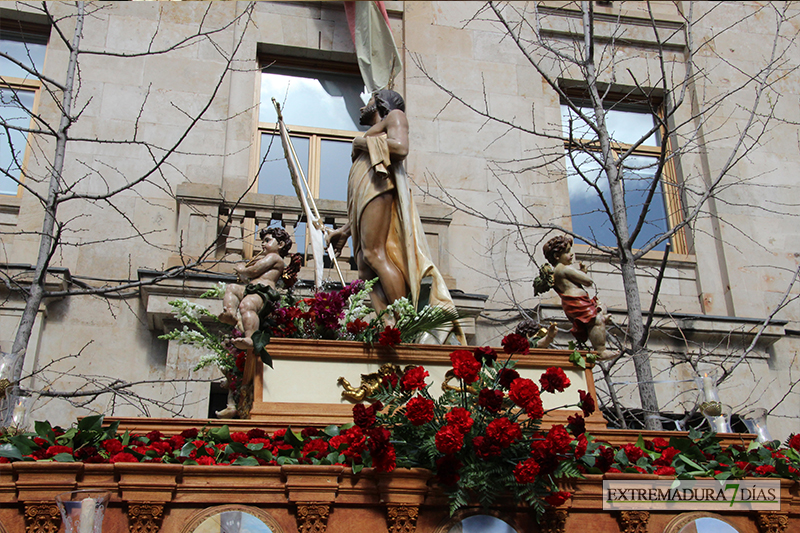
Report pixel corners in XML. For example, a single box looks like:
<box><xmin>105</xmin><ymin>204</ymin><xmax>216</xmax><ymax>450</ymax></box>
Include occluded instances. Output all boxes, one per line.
<box><xmin>561</xmin><ymin>104</ymin><xmax>660</xmax><ymax>146</ymax></box>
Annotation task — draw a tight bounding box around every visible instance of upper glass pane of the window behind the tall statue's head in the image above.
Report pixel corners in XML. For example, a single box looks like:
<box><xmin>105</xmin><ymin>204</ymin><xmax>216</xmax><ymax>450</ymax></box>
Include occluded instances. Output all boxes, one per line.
<box><xmin>259</xmin><ymin>67</ymin><xmax>369</xmax><ymax>131</ymax></box>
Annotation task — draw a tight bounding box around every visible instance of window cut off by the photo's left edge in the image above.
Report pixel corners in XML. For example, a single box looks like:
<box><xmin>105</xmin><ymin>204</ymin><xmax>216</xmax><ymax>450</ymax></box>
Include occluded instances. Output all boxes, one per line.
<box><xmin>0</xmin><ymin>20</ymin><xmax>48</xmax><ymax>195</ymax></box>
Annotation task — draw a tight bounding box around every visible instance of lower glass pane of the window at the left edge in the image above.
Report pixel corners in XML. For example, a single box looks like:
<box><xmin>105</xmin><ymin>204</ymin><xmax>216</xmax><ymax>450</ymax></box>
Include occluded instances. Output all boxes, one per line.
<box><xmin>0</xmin><ymin>89</ymin><xmax>34</xmax><ymax>194</ymax></box>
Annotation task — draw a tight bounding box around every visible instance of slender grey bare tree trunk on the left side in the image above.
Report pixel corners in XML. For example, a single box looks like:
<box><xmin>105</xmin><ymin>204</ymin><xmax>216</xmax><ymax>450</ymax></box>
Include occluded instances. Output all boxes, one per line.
<box><xmin>11</xmin><ymin>2</ymin><xmax>84</xmax><ymax>388</ymax></box>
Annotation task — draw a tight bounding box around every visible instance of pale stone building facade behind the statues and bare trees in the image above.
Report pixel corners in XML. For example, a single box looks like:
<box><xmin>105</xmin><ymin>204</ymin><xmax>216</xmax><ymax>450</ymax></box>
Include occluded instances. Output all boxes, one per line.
<box><xmin>0</xmin><ymin>2</ymin><xmax>800</xmax><ymax>439</ymax></box>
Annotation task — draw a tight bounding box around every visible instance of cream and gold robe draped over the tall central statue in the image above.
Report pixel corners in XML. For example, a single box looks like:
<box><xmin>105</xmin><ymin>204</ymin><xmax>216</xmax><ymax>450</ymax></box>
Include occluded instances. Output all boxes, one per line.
<box><xmin>347</xmin><ymin>133</ymin><xmax>466</xmax><ymax>338</ymax></box>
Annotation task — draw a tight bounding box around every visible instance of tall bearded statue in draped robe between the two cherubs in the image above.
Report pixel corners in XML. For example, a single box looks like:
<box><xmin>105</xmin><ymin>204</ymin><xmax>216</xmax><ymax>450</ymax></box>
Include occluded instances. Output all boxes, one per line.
<box><xmin>328</xmin><ymin>89</ymin><xmax>466</xmax><ymax>344</ymax></box>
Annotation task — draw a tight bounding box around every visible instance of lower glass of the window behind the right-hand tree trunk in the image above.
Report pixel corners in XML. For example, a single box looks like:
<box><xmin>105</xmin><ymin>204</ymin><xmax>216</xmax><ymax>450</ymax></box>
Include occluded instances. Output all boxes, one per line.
<box><xmin>566</xmin><ymin>153</ymin><xmax>667</xmax><ymax>250</ymax></box>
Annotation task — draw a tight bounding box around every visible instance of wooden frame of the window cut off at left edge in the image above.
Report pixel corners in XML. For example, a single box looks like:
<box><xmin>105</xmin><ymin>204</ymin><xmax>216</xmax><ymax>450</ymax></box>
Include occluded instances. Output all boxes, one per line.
<box><xmin>0</xmin><ymin>19</ymin><xmax>50</xmax><ymax>198</ymax></box>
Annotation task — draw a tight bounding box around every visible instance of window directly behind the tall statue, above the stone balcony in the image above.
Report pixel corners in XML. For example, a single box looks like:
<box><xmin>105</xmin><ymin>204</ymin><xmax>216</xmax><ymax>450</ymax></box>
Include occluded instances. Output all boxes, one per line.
<box><xmin>258</xmin><ymin>61</ymin><xmax>369</xmax><ymax>201</ymax></box>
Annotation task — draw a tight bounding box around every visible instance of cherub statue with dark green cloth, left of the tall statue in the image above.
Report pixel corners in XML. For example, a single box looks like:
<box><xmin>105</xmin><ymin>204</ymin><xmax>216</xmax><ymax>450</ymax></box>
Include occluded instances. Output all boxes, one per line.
<box><xmin>219</xmin><ymin>227</ymin><xmax>292</xmax><ymax>350</ymax></box>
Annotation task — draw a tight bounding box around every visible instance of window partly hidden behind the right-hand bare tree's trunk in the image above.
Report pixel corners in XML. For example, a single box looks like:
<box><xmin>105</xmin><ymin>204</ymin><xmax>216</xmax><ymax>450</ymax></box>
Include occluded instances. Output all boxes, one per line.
<box><xmin>561</xmin><ymin>99</ymin><xmax>687</xmax><ymax>253</ymax></box>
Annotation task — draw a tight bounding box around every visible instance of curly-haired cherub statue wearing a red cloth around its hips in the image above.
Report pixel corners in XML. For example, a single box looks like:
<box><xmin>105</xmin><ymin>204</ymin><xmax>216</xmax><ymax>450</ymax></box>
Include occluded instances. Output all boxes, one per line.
<box><xmin>542</xmin><ymin>235</ymin><xmax>619</xmax><ymax>359</ymax></box>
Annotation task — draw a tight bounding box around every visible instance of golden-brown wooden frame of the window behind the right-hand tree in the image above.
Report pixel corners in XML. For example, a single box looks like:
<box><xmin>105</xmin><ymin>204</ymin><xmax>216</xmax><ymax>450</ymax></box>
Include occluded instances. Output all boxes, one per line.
<box><xmin>559</xmin><ymin>90</ymin><xmax>689</xmax><ymax>255</ymax></box>
